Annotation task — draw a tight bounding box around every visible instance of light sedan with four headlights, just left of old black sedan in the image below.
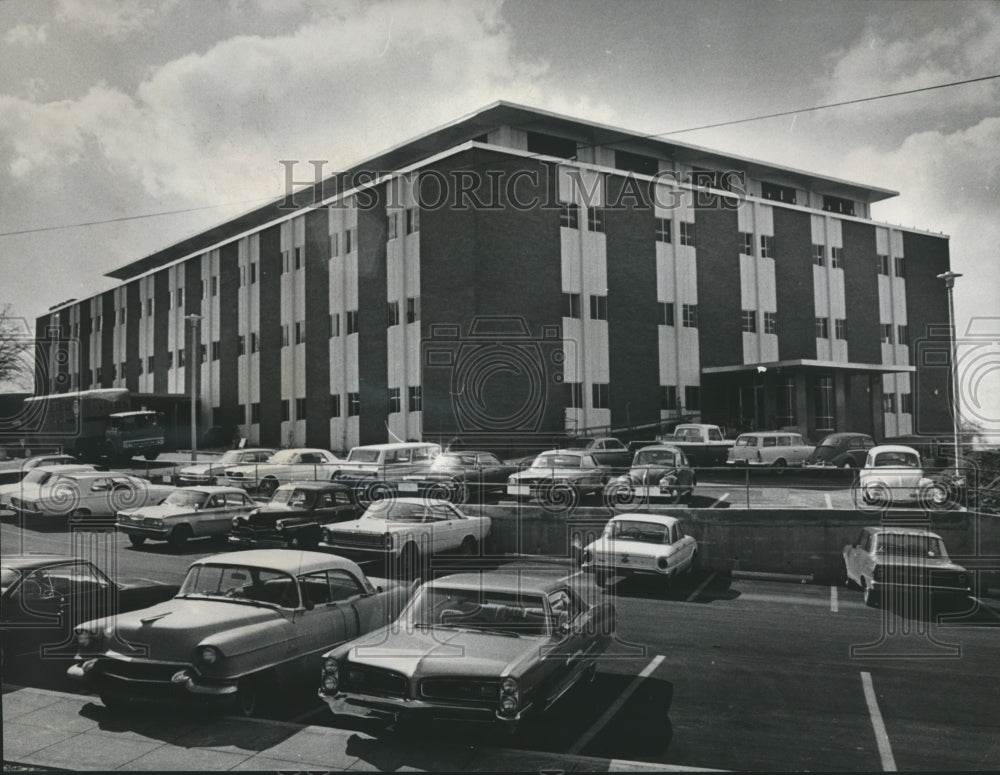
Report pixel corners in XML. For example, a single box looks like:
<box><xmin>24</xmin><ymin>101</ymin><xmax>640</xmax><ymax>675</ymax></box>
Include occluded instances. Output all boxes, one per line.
<box><xmin>118</xmin><ymin>486</ymin><xmax>257</xmax><ymax>549</ymax></box>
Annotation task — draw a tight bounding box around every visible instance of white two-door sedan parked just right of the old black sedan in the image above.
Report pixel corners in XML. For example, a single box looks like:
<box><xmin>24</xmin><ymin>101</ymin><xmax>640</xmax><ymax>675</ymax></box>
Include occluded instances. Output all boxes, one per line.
<box><xmin>320</xmin><ymin>498</ymin><xmax>490</xmax><ymax>576</ymax></box>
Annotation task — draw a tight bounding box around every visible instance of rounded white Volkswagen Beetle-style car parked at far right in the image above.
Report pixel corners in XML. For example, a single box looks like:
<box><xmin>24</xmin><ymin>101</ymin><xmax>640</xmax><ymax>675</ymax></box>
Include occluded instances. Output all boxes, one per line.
<box><xmin>856</xmin><ymin>444</ymin><xmax>948</xmax><ymax>508</ymax></box>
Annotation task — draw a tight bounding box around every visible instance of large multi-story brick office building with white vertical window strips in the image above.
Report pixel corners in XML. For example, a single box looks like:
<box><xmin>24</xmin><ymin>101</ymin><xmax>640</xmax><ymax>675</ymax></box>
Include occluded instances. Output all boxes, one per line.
<box><xmin>37</xmin><ymin>103</ymin><xmax>950</xmax><ymax>449</ymax></box>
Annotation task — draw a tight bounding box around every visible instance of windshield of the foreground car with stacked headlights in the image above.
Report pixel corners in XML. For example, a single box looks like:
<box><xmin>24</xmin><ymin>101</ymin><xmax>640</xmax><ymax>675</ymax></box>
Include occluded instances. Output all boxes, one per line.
<box><xmin>402</xmin><ymin>585</ymin><xmax>552</xmax><ymax>635</ymax></box>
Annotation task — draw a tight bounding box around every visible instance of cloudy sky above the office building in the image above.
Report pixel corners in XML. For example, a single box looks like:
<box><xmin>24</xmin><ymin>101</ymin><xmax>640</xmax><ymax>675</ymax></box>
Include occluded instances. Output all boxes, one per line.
<box><xmin>0</xmin><ymin>0</ymin><xmax>1000</xmax><ymax>432</ymax></box>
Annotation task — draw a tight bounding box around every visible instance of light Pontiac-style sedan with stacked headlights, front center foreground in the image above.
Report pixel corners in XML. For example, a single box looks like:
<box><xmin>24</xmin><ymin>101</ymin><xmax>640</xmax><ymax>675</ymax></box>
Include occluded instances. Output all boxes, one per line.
<box><xmin>319</xmin><ymin>572</ymin><xmax>615</xmax><ymax>730</ymax></box>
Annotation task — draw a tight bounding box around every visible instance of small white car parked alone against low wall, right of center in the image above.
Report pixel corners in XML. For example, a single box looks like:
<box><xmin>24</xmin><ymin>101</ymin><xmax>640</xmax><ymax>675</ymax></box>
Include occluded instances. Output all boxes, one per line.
<box><xmin>581</xmin><ymin>513</ymin><xmax>698</xmax><ymax>587</ymax></box>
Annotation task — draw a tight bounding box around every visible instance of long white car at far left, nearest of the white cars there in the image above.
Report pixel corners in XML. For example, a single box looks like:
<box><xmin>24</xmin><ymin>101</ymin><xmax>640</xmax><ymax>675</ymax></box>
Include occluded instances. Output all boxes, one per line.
<box><xmin>11</xmin><ymin>471</ymin><xmax>177</xmax><ymax>520</ymax></box>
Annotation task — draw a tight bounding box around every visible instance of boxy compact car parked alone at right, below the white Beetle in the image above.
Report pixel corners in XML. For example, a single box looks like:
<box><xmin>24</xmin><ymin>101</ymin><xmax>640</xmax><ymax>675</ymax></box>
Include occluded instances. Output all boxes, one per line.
<box><xmin>844</xmin><ymin>526</ymin><xmax>971</xmax><ymax>606</ymax></box>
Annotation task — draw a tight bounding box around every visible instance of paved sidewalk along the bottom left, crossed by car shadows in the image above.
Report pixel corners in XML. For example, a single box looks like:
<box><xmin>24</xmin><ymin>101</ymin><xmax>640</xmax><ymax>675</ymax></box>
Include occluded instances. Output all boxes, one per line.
<box><xmin>2</xmin><ymin>686</ymin><xmax>720</xmax><ymax>775</ymax></box>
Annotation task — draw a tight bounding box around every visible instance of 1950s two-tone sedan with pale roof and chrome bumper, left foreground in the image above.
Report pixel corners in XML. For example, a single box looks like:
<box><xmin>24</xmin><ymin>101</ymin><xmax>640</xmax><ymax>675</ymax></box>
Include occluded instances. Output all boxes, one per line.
<box><xmin>68</xmin><ymin>549</ymin><xmax>409</xmax><ymax>716</ymax></box>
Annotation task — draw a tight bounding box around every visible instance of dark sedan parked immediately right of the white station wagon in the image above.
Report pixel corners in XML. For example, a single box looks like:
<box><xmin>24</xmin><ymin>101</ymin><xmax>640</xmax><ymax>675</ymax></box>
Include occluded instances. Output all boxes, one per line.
<box><xmin>395</xmin><ymin>449</ymin><xmax>518</xmax><ymax>505</ymax></box>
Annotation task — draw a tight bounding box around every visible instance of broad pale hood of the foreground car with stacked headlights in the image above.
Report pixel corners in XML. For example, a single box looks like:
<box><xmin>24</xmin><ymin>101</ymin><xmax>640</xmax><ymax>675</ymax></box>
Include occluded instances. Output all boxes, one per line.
<box><xmin>347</xmin><ymin>625</ymin><xmax>548</xmax><ymax>679</ymax></box>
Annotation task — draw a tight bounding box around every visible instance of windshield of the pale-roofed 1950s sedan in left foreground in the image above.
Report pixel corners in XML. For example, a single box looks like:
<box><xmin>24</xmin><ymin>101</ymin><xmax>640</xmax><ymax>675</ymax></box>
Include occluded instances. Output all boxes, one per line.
<box><xmin>177</xmin><ymin>563</ymin><xmax>299</xmax><ymax>608</ymax></box>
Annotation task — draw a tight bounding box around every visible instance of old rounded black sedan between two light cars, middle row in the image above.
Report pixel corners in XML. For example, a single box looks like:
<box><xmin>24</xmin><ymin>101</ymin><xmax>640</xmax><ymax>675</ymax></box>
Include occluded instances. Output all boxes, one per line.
<box><xmin>229</xmin><ymin>482</ymin><xmax>365</xmax><ymax>549</ymax></box>
